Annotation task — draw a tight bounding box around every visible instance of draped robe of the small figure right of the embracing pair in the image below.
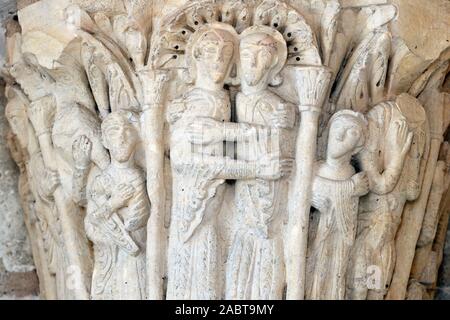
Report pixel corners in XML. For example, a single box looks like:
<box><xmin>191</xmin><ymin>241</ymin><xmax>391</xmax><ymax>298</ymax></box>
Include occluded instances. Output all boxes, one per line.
<box><xmin>306</xmin><ymin>165</ymin><xmax>359</xmax><ymax>300</ymax></box>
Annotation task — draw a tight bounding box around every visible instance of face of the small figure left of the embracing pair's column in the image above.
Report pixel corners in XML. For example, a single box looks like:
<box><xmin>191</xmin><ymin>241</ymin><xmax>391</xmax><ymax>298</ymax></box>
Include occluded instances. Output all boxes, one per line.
<box><xmin>103</xmin><ymin>115</ymin><xmax>138</xmax><ymax>162</ymax></box>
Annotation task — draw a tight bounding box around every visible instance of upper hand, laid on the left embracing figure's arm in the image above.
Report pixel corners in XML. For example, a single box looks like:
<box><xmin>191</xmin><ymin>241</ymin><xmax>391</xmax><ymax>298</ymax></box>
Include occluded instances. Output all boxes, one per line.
<box><xmin>186</xmin><ymin>118</ymin><xmax>224</xmax><ymax>145</ymax></box>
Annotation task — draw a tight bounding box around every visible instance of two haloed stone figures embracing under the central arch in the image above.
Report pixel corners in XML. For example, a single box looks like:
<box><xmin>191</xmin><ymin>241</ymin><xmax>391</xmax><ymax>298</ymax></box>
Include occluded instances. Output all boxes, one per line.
<box><xmin>167</xmin><ymin>23</ymin><xmax>296</xmax><ymax>299</ymax></box>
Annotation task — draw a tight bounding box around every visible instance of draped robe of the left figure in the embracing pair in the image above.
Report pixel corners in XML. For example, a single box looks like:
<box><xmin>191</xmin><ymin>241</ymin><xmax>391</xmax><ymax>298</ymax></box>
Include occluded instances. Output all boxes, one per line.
<box><xmin>167</xmin><ymin>88</ymin><xmax>231</xmax><ymax>300</ymax></box>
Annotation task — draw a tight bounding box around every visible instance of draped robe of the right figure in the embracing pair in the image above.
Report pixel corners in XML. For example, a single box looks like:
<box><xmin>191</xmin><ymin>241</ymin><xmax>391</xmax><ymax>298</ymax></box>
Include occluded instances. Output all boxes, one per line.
<box><xmin>226</xmin><ymin>90</ymin><xmax>295</xmax><ymax>300</ymax></box>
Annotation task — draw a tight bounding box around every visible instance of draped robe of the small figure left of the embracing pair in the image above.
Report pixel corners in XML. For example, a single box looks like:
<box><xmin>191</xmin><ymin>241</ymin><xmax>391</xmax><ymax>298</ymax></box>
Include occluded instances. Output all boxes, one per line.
<box><xmin>85</xmin><ymin>165</ymin><xmax>150</xmax><ymax>300</ymax></box>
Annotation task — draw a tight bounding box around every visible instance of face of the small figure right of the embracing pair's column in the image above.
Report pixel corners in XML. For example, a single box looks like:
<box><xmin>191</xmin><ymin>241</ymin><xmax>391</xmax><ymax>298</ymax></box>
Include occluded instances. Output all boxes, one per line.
<box><xmin>327</xmin><ymin>117</ymin><xmax>363</xmax><ymax>159</ymax></box>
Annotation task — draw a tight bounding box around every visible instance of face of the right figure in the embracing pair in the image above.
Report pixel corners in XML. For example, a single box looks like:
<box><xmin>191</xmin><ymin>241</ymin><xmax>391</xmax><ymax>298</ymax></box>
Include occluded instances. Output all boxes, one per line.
<box><xmin>240</xmin><ymin>33</ymin><xmax>276</xmax><ymax>86</ymax></box>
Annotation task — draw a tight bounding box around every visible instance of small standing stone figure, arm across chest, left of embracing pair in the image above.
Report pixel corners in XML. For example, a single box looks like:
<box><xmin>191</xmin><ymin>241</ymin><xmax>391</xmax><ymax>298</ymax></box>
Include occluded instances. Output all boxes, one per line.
<box><xmin>86</xmin><ymin>113</ymin><xmax>150</xmax><ymax>300</ymax></box>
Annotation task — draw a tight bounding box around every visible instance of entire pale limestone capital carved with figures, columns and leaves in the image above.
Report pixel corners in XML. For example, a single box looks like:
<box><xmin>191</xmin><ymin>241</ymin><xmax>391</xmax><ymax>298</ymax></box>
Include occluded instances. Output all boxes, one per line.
<box><xmin>1</xmin><ymin>0</ymin><xmax>450</xmax><ymax>300</ymax></box>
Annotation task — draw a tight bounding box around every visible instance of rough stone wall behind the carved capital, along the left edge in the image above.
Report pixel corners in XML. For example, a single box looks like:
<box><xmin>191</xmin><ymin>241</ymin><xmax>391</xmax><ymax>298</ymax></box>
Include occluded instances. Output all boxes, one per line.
<box><xmin>0</xmin><ymin>0</ymin><xmax>39</xmax><ymax>299</ymax></box>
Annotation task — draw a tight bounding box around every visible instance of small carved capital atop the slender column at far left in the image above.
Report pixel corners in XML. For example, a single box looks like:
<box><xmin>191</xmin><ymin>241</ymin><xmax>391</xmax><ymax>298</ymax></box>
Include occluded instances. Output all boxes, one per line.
<box><xmin>28</xmin><ymin>97</ymin><xmax>56</xmax><ymax>135</ymax></box>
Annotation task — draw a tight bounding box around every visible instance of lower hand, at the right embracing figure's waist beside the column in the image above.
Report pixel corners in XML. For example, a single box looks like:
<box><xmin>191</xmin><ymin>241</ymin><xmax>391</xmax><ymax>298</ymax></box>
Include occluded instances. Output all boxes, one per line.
<box><xmin>256</xmin><ymin>154</ymin><xmax>294</xmax><ymax>180</ymax></box>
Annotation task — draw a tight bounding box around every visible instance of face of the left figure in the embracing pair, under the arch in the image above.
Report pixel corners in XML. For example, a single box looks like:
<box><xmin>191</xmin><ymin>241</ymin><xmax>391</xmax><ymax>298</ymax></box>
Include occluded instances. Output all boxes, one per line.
<box><xmin>194</xmin><ymin>30</ymin><xmax>235</xmax><ymax>83</ymax></box>
